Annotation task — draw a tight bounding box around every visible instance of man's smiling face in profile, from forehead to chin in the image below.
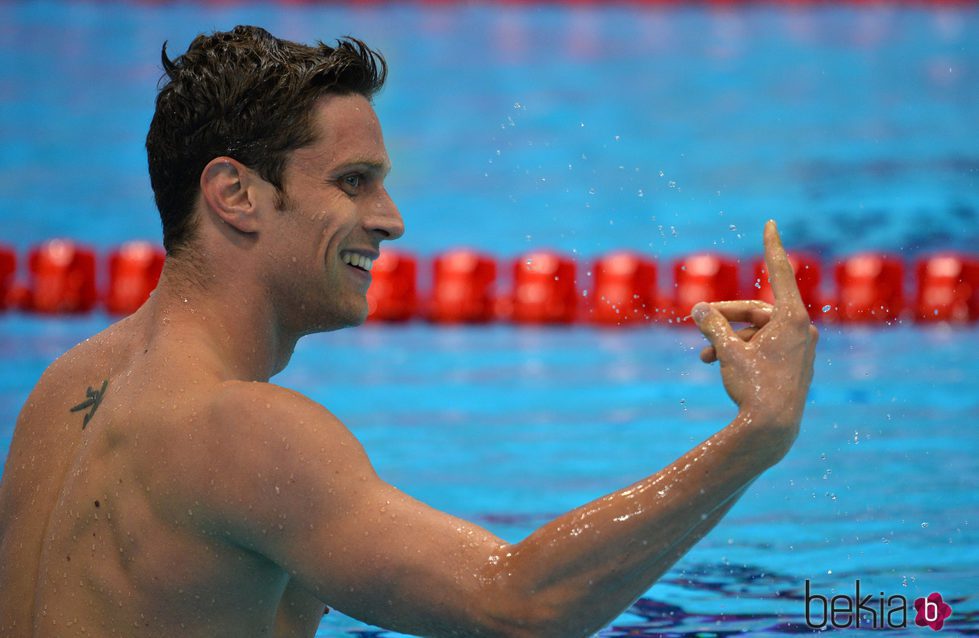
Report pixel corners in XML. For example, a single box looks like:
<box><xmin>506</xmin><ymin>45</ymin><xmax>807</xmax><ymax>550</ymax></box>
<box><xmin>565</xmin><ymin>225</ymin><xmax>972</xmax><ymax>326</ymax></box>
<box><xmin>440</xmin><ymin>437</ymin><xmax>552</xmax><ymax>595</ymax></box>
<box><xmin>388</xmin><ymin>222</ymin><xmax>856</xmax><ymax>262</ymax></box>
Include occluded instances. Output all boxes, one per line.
<box><xmin>265</xmin><ymin>95</ymin><xmax>404</xmax><ymax>333</ymax></box>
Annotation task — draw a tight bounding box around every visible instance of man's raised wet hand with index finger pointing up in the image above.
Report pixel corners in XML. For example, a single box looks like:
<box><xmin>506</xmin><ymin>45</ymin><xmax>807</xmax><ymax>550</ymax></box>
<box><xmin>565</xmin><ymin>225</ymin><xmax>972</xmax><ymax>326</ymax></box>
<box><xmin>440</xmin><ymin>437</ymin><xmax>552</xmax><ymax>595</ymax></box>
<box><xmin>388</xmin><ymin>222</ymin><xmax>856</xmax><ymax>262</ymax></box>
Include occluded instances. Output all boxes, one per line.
<box><xmin>692</xmin><ymin>221</ymin><xmax>819</xmax><ymax>454</ymax></box>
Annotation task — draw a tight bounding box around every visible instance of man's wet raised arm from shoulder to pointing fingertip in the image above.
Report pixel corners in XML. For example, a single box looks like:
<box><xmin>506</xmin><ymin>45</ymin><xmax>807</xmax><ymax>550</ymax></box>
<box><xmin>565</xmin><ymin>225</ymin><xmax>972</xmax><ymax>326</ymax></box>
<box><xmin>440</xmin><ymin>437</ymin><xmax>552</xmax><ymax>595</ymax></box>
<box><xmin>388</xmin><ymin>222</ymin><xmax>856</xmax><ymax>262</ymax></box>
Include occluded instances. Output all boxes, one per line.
<box><xmin>188</xmin><ymin>223</ymin><xmax>817</xmax><ymax>638</ymax></box>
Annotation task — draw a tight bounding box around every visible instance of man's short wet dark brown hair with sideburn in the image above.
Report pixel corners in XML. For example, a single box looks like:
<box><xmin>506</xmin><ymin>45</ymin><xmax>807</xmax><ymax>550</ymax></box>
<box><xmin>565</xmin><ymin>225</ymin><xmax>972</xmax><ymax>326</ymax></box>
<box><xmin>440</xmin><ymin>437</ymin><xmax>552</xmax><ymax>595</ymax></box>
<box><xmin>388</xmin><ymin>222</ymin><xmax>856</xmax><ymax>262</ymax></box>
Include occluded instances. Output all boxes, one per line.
<box><xmin>146</xmin><ymin>26</ymin><xmax>387</xmax><ymax>255</ymax></box>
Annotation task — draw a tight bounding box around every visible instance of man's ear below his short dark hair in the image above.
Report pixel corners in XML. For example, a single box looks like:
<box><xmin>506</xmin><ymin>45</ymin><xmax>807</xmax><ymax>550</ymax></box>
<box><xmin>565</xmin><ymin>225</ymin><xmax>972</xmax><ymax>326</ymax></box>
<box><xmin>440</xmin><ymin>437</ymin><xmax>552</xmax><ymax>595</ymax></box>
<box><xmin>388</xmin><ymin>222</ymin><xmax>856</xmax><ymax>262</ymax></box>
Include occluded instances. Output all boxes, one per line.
<box><xmin>201</xmin><ymin>156</ymin><xmax>271</xmax><ymax>233</ymax></box>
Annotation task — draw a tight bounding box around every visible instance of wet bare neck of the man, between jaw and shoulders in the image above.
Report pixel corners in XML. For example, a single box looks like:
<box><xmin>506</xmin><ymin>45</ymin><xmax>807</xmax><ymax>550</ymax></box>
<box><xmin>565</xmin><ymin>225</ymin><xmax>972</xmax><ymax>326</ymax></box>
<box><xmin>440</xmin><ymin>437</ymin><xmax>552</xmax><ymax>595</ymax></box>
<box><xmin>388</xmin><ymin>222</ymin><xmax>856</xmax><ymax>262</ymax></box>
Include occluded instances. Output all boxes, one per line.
<box><xmin>140</xmin><ymin>257</ymin><xmax>301</xmax><ymax>381</ymax></box>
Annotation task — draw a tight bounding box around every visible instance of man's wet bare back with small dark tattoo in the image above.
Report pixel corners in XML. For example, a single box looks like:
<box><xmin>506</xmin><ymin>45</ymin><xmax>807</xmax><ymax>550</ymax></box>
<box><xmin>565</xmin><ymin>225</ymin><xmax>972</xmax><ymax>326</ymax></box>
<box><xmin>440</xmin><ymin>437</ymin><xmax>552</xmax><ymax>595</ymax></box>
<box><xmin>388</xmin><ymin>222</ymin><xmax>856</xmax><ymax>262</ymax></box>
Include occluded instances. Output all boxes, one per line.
<box><xmin>0</xmin><ymin>317</ymin><xmax>323</xmax><ymax>637</ymax></box>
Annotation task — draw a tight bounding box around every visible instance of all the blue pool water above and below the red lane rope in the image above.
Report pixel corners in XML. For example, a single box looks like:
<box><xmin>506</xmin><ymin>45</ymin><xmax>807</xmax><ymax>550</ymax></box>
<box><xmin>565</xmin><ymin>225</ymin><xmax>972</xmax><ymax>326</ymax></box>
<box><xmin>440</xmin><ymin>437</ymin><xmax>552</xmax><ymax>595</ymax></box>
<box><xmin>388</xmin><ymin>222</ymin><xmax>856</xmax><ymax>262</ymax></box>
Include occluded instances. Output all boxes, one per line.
<box><xmin>0</xmin><ymin>3</ymin><xmax>979</xmax><ymax>636</ymax></box>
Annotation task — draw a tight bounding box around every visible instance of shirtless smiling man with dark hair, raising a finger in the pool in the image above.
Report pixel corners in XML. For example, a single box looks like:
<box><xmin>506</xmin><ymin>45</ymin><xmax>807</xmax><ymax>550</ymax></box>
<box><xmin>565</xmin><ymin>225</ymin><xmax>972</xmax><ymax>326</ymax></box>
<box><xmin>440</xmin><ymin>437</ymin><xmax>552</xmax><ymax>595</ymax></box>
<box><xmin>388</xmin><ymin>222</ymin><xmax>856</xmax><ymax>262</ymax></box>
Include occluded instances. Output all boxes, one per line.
<box><xmin>0</xmin><ymin>27</ymin><xmax>817</xmax><ymax>638</ymax></box>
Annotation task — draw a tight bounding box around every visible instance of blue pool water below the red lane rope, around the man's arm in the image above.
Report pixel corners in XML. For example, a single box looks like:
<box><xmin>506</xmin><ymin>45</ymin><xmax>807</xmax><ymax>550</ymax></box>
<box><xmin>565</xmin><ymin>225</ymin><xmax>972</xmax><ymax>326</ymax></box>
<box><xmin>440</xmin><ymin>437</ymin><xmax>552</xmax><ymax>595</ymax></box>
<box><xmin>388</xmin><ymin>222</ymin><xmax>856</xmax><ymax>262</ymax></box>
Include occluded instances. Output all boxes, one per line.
<box><xmin>0</xmin><ymin>317</ymin><xmax>979</xmax><ymax>636</ymax></box>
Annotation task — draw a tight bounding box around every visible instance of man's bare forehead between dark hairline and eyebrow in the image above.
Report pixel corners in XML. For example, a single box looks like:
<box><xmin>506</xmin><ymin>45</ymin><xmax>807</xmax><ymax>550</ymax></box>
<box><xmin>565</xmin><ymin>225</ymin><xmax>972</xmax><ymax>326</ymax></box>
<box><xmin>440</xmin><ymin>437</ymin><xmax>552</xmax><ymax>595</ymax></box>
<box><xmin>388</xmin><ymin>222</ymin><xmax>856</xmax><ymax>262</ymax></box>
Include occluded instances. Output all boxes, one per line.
<box><xmin>292</xmin><ymin>94</ymin><xmax>390</xmax><ymax>170</ymax></box>
